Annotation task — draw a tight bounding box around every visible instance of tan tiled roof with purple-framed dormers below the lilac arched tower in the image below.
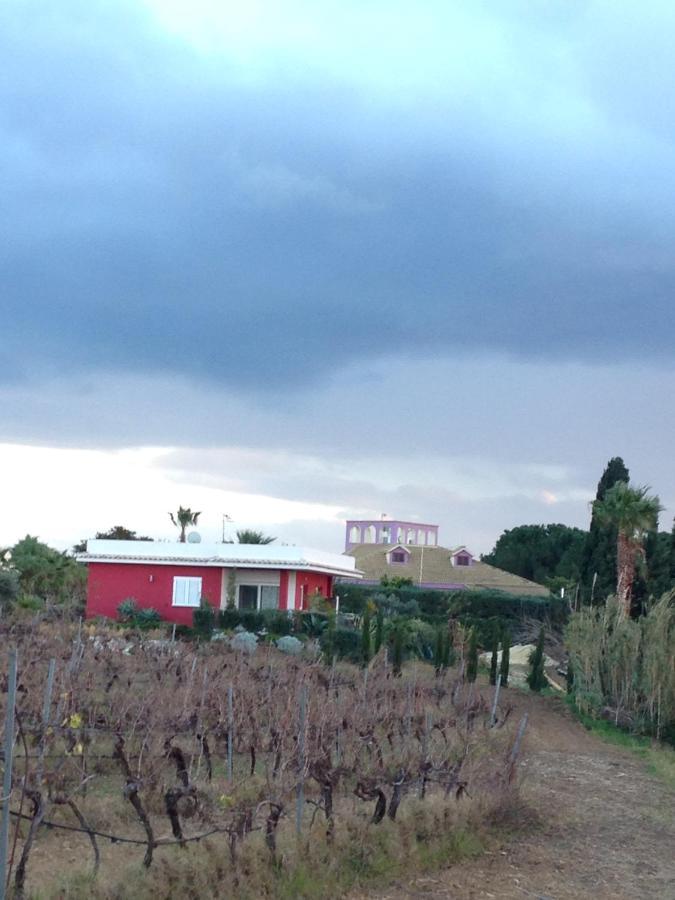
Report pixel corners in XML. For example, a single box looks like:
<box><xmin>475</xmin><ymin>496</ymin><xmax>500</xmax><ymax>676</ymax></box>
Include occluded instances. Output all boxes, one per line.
<box><xmin>345</xmin><ymin>544</ymin><xmax>549</xmax><ymax>597</ymax></box>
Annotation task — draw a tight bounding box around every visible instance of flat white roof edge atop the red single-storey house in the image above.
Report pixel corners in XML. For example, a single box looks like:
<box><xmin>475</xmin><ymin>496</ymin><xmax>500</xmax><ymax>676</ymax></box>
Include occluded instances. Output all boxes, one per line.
<box><xmin>77</xmin><ymin>540</ymin><xmax>361</xmax><ymax>578</ymax></box>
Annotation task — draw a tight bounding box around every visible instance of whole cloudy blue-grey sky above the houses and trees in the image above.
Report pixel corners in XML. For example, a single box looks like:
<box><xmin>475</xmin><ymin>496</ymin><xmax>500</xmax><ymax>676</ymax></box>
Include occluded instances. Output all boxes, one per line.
<box><xmin>0</xmin><ymin>0</ymin><xmax>675</xmax><ymax>552</ymax></box>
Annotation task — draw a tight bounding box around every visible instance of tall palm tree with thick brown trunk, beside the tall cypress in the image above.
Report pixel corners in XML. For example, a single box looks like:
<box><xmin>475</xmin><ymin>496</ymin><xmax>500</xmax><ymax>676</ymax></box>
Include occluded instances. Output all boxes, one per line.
<box><xmin>593</xmin><ymin>481</ymin><xmax>663</xmax><ymax>616</ymax></box>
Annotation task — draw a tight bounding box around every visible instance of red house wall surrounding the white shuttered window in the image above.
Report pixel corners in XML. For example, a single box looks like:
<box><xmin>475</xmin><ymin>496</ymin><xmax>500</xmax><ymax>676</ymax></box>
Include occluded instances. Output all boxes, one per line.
<box><xmin>87</xmin><ymin>563</ymin><xmax>222</xmax><ymax>625</ymax></box>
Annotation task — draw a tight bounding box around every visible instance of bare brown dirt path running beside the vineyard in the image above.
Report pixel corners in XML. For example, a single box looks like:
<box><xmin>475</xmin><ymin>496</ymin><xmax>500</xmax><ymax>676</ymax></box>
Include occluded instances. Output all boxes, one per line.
<box><xmin>356</xmin><ymin>691</ymin><xmax>675</xmax><ymax>900</ymax></box>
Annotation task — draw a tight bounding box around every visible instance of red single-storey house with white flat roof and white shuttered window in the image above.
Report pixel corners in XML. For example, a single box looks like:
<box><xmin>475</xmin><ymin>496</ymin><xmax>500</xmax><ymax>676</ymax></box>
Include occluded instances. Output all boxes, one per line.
<box><xmin>78</xmin><ymin>540</ymin><xmax>360</xmax><ymax>625</ymax></box>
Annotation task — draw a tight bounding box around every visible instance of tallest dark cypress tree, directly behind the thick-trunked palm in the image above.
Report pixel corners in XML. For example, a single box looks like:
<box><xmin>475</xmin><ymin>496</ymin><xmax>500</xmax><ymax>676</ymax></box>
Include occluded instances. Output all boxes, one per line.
<box><xmin>581</xmin><ymin>456</ymin><xmax>630</xmax><ymax>603</ymax></box>
